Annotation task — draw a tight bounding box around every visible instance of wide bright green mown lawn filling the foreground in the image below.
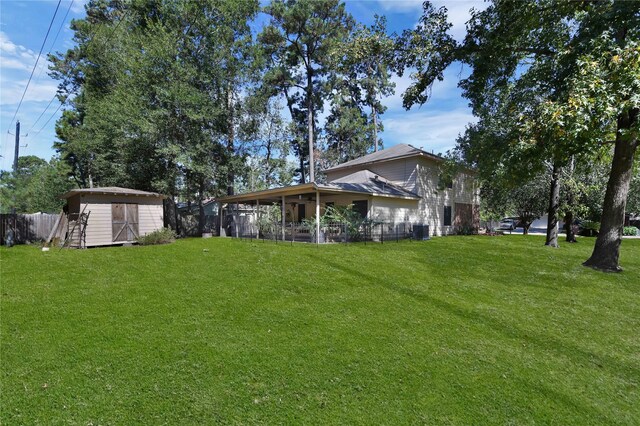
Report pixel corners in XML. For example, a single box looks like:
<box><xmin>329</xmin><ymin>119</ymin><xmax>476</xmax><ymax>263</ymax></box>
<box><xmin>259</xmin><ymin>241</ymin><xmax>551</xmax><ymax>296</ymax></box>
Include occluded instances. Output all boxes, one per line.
<box><xmin>0</xmin><ymin>236</ymin><xmax>640</xmax><ymax>425</ymax></box>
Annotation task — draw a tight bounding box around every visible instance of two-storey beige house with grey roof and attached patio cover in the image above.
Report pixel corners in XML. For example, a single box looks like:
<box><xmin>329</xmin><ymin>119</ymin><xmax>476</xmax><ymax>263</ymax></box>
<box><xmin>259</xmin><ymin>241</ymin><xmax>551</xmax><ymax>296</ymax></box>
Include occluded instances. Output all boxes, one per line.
<box><xmin>219</xmin><ymin>144</ymin><xmax>479</xmax><ymax>241</ymax></box>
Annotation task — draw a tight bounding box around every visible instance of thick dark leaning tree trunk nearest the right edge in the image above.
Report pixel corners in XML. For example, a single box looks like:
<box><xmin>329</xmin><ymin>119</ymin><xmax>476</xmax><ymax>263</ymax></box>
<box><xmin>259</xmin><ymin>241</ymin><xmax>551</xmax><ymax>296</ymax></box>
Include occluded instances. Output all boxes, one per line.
<box><xmin>583</xmin><ymin>110</ymin><xmax>638</xmax><ymax>272</ymax></box>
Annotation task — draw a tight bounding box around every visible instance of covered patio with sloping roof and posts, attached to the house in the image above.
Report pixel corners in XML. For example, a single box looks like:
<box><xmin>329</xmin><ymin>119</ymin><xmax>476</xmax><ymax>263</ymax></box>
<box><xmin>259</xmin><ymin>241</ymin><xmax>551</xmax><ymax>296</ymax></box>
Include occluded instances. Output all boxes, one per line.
<box><xmin>219</xmin><ymin>174</ymin><xmax>420</xmax><ymax>243</ymax></box>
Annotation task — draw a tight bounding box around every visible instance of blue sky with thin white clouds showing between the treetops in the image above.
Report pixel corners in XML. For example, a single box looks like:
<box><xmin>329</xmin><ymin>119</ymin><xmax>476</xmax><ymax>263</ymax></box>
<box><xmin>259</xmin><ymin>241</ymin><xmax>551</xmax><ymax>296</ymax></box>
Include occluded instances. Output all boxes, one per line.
<box><xmin>0</xmin><ymin>0</ymin><xmax>486</xmax><ymax>170</ymax></box>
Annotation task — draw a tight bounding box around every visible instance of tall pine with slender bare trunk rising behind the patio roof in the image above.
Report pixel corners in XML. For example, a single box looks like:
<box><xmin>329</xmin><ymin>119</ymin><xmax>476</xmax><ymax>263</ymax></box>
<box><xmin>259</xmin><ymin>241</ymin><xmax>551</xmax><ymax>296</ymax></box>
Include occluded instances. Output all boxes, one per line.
<box><xmin>259</xmin><ymin>0</ymin><xmax>353</xmax><ymax>182</ymax></box>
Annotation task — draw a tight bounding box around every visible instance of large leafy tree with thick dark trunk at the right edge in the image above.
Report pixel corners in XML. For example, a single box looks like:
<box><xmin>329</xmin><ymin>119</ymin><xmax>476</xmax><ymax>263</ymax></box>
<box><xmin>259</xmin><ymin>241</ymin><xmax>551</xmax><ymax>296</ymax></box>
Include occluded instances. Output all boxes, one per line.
<box><xmin>404</xmin><ymin>0</ymin><xmax>640</xmax><ymax>270</ymax></box>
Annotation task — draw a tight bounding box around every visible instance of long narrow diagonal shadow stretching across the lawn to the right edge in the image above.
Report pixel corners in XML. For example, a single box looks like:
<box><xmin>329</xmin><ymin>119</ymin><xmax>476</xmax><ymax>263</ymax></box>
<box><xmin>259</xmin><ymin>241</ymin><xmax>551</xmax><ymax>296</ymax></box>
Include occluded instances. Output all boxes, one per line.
<box><xmin>316</xmin><ymin>253</ymin><xmax>640</xmax><ymax>381</ymax></box>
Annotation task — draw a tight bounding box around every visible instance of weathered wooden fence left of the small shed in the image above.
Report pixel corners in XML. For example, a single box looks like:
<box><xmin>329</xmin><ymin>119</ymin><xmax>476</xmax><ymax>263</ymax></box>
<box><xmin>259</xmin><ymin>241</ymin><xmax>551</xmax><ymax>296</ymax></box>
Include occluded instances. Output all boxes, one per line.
<box><xmin>0</xmin><ymin>213</ymin><xmax>59</xmax><ymax>245</ymax></box>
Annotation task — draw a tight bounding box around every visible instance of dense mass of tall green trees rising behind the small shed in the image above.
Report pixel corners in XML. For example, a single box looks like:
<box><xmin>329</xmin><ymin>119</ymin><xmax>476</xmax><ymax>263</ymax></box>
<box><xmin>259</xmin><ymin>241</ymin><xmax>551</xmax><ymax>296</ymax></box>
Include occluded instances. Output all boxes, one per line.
<box><xmin>52</xmin><ymin>0</ymin><xmax>258</xmax><ymax>200</ymax></box>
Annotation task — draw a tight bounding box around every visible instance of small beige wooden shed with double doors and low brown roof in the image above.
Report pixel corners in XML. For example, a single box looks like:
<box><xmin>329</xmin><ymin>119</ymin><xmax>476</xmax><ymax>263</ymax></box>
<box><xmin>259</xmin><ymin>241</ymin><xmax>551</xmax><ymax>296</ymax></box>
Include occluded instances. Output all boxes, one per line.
<box><xmin>62</xmin><ymin>187</ymin><xmax>164</xmax><ymax>247</ymax></box>
